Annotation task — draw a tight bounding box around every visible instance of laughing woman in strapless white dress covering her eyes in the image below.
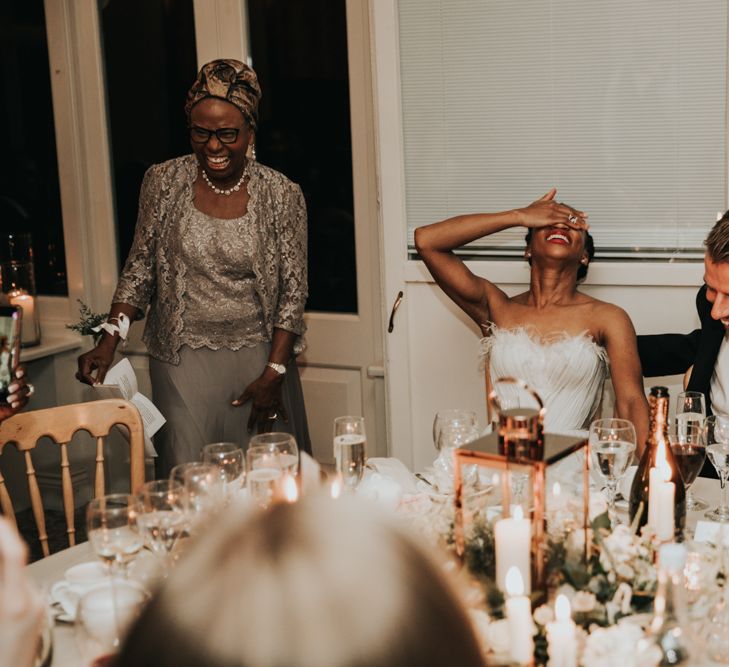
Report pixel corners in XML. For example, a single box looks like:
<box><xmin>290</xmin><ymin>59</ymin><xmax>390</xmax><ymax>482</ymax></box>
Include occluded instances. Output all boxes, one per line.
<box><xmin>415</xmin><ymin>189</ymin><xmax>648</xmax><ymax>448</ymax></box>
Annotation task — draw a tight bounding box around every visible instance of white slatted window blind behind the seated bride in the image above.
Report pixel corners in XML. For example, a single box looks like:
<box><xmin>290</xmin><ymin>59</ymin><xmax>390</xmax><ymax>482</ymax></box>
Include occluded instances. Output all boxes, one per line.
<box><xmin>398</xmin><ymin>0</ymin><xmax>727</xmax><ymax>258</ymax></box>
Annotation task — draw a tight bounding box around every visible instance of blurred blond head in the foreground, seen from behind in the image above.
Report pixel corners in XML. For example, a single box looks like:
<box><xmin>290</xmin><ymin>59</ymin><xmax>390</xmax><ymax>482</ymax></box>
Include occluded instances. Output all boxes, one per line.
<box><xmin>117</xmin><ymin>498</ymin><xmax>484</xmax><ymax>667</ymax></box>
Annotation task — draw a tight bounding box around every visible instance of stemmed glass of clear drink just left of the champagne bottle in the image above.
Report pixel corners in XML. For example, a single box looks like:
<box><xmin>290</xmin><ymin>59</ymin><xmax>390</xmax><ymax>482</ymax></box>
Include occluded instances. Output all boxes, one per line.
<box><xmin>589</xmin><ymin>418</ymin><xmax>636</xmax><ymax>528</ymax></box>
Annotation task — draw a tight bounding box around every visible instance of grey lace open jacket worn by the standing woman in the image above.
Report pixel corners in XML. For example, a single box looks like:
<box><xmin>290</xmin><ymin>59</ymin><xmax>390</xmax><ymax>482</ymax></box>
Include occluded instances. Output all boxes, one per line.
<box><xmin>113</xmin><ymin>155</ymin><xmax>308</xmax><ymax>364</ymax></box>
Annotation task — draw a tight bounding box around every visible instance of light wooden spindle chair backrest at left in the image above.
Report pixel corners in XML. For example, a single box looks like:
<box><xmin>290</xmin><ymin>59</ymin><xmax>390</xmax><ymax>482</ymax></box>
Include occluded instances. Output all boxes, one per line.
<box><xmin>0</xmin><ymin>398</ymin><xmax>144</xmax><ymax>556</ymax></box>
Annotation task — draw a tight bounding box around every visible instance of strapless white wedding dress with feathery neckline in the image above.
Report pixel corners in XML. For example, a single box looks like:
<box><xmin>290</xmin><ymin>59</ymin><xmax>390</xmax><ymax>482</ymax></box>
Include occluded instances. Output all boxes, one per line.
<box><xmin>481</xmin><ymin>325</ymin><xmax>609</xmax><ymax>434</ymax></box>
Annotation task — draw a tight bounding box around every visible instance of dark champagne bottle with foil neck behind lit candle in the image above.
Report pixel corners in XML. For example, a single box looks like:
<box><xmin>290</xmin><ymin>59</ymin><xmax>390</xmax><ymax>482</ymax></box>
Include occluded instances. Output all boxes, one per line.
<box><xmin>630</xmin><ymin>387</ymin><xmax>686</xmax><ymax>541</ymax></box>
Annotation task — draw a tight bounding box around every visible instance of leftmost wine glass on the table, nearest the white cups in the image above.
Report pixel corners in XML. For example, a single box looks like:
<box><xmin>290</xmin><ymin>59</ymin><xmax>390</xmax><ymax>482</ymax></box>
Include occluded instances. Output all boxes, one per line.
<box><xmin>86</xmin><ymin>493</ymin><xmax>143</xmax><ymax>576</ymax></box>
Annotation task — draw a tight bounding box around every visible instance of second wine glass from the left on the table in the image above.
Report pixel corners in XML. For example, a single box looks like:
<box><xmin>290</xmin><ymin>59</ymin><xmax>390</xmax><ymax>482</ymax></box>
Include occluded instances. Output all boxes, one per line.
<box><xmin>137</xmin><ymin>479</ymin><xmax>189</xmax><ymax>563</ymax></box>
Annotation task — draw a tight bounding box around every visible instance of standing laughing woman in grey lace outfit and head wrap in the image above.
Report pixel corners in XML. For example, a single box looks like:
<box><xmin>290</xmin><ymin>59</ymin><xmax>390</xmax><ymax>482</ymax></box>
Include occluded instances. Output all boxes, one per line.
<box><xmin>77</xmin><ymin>60</ymin><xmax>311</xmax><ymax>475</ymax></box>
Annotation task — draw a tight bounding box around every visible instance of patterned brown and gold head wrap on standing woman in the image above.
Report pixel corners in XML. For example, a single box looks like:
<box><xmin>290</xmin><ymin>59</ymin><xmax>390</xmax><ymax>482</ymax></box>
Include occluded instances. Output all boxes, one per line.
<box><xmin>185</xmin><ymin>59</ymin><xmax>261</xmax><ymax>130</ymax></box>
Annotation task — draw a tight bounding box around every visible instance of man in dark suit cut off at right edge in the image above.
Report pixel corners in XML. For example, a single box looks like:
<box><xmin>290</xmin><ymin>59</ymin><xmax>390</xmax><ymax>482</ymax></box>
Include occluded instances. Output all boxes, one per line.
<box><xmin>638</xmin><ymin>211</ymin><xmax>729</xmax><ymax>477</ymax></box>
